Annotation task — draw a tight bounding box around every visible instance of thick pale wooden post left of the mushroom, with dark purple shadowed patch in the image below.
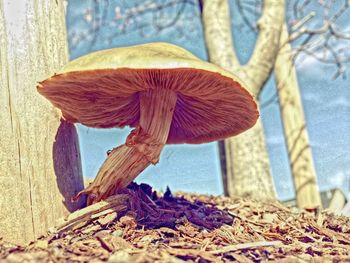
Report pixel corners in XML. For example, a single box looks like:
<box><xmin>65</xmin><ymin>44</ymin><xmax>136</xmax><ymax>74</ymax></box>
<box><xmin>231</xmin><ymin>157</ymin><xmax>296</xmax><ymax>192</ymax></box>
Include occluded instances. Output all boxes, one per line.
<box><xmin>0</xmin><ymin>0</ymin><xmax>83</xmax><ymax>243</ymax></box>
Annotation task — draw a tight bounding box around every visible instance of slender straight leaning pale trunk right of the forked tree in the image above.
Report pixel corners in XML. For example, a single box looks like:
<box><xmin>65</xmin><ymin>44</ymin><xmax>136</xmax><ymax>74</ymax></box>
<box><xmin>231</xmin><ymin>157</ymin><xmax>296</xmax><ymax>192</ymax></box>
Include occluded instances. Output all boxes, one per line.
<box><xmin>275</xmin><ymin>25</ymin><xmax>322</xmax><ymax>208</ymax></box>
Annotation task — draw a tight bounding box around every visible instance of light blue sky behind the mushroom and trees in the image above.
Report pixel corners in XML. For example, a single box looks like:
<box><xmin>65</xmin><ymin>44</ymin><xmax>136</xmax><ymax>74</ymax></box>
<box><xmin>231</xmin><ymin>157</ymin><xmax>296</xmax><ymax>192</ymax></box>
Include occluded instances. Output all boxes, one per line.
<box><xmin>67</xmin><ymin>0</ymin><xmax>350</xmax><ymax>199</ymax></box>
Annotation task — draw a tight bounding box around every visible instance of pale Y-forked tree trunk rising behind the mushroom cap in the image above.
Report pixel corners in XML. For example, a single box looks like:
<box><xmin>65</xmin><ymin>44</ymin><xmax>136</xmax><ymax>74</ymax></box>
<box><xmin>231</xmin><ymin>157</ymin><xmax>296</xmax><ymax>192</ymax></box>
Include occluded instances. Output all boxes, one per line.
<box><xmin>202</xmin><ymin>0</ymin><xmax>285</xmax><ymax>200</ymax></box>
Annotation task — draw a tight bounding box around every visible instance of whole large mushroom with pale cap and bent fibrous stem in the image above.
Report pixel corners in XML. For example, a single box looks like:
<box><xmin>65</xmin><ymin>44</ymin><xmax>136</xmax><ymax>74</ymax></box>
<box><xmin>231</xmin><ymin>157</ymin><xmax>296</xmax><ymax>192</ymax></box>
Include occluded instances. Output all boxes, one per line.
<box><xmin>37</xmin><ymin>43</ymin><xmax>259</xmax><ymax>204</ymax></box>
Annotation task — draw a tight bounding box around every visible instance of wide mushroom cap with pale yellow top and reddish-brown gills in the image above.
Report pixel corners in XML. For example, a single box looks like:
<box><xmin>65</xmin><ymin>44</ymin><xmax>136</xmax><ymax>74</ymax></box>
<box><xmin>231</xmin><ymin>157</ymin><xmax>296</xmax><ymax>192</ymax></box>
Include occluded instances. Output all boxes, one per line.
<box><xmin>38</xmin><ymin>43</ymin><xmax>259</xmax><ymax>143</ymax></box>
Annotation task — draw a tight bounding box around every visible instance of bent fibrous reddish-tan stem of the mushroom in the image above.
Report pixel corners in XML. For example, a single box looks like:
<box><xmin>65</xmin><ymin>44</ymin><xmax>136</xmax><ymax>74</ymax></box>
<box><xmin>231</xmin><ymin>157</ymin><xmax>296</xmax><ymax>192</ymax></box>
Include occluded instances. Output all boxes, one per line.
<box><xmin>73</xmin><ymin>89</ymin><xmax>177</xmax><ymax>205</ymax></box>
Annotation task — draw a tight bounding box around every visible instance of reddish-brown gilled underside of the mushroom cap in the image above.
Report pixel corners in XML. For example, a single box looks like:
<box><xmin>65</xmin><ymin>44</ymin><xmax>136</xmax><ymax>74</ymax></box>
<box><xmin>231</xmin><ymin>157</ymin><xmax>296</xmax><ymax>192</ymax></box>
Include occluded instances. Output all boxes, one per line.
<box><xmin>38</xmin><ymin>68</ymin><xmax>259</xmax><ymax>143</ymax></box>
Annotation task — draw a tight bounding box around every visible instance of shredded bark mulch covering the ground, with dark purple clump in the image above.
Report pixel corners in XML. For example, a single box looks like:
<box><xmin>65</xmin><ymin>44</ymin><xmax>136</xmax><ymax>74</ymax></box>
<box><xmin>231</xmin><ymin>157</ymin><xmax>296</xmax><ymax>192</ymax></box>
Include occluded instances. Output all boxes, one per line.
<box><xmin>0</xmin><ymin>184</ymin><xmax>350</xmax><ymax>263</ymax></box>
